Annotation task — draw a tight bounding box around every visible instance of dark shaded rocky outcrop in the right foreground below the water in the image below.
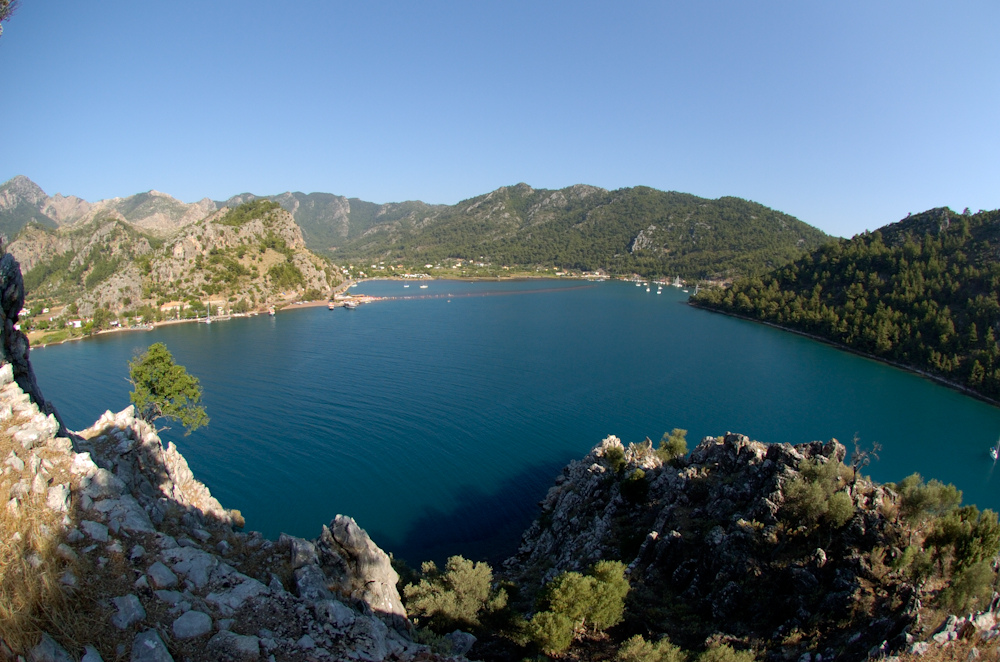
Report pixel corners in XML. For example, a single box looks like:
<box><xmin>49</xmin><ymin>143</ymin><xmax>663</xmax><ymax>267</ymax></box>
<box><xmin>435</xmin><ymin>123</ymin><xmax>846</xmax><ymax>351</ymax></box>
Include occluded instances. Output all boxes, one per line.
<box><xmin>504</xmin><ymin>433</ymin><xmax>919</xmax><ymax>660</ymax></box>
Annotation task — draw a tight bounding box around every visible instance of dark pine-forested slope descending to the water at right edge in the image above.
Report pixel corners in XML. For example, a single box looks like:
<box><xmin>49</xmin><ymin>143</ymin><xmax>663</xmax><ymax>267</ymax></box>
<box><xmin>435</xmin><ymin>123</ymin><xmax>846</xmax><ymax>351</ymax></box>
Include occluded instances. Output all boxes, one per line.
<box><xmin>693</xmin><ymin>208</ymin><xmax>1000</xmax><ymax>400</ymax></box>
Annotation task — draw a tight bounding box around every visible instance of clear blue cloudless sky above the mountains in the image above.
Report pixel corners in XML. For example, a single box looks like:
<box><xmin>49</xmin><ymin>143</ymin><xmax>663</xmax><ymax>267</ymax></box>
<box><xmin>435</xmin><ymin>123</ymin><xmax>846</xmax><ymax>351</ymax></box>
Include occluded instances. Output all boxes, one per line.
<box><xmin>0</xmin><ymin>0</ymin><xmax>1000</xmax><ymax>236</ymax></box>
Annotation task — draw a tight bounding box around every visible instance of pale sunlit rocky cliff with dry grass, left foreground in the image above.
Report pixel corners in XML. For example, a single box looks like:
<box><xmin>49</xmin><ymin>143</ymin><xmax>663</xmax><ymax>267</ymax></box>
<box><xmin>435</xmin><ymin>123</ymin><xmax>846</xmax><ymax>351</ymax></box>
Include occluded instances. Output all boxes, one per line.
<box><xmin>0</xmin><ymin>255</ymin><xmax>458</xmax><ymax>662</ymax></box>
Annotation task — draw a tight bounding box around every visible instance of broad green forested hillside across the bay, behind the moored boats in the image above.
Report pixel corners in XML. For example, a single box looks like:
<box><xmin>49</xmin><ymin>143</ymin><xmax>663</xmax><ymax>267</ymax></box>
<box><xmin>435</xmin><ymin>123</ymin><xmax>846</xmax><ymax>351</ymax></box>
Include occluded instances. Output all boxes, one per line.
<box><xmin>334</xmin><ymin>184</ymin><xmax>827</xmax><ymax>278</ymax></box>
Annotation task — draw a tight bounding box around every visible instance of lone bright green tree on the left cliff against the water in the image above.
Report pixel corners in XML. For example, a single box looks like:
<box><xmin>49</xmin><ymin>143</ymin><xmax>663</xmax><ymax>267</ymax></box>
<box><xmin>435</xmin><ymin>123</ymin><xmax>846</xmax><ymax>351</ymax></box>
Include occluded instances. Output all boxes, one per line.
<box><xmin>128</xmin><ymin>342</ymin><xmax>208</xmax><ymax>435</ymax></box>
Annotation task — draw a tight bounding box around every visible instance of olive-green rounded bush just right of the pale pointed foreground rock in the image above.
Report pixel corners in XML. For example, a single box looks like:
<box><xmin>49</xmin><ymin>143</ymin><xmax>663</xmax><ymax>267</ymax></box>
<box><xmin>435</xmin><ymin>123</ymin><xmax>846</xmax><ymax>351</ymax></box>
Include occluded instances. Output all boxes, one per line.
<box><xmin>403</xmin><ymin>556</ymin><xmax>507</xmax><ymax>633</ymax></box>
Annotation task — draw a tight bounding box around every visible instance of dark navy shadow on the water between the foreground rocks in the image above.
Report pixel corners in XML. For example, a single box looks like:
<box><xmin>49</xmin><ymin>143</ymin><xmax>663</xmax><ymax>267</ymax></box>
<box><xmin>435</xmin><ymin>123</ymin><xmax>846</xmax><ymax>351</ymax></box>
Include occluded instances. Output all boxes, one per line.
<box><xmin>384</xmin><ymin>462</ymin><xmax>566</xmax><ymax>568</ymax></box>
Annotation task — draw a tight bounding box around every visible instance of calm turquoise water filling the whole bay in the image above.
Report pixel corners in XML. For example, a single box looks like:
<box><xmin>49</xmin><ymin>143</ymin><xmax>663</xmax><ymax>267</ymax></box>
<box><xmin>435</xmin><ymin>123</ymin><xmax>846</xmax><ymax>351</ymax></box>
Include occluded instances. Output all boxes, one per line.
<box><xmin>31</xmin><ymin>281</ymin><xmax>1000</xmax><ymax>563</ymax></box>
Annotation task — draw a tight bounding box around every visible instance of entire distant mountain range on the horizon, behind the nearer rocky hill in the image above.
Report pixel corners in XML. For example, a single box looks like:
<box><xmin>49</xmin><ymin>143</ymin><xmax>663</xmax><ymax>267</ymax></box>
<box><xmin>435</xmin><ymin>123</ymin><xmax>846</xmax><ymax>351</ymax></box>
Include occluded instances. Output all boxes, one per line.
<box><xmin>0</xmin><ymin>176</ymin><xmax>830</xmax><ymax>278</ymax></box>
